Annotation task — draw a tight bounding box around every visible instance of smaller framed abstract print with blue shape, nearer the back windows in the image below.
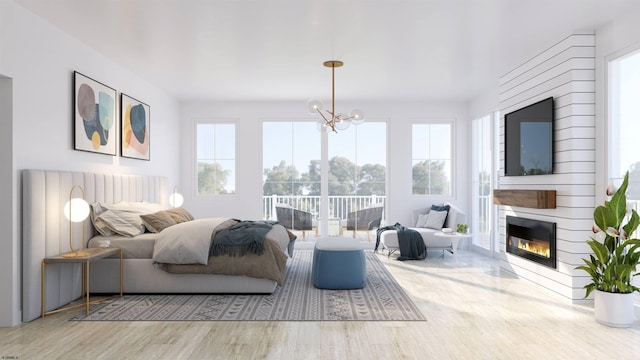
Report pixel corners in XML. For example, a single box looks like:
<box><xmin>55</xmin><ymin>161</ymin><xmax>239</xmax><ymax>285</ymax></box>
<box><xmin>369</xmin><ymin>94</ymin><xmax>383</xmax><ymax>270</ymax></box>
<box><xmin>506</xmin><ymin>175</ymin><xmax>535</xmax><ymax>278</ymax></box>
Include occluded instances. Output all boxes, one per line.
<box><xmin>120</xmin><ymin>94</ymin><xmax>151</xmax><ymax>160</ymax></box>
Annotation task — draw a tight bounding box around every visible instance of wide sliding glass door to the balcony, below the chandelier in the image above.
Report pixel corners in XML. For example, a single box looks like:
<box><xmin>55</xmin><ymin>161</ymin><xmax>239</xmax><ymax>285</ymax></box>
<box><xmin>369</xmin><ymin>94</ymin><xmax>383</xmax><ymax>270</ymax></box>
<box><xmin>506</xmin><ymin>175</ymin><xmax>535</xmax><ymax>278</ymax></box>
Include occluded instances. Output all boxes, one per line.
<box><xmin>262</xmin><ymin>121</ymin><xmax>387</xmax><ymax>240</ymax></box>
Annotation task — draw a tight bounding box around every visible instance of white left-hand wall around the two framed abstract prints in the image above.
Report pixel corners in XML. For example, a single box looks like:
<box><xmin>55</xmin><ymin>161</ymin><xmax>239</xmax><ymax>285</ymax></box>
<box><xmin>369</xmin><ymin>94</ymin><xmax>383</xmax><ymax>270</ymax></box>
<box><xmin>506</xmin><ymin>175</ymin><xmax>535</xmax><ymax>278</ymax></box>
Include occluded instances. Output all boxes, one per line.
<box><xmin>0</xmin><ymin>1</ymin><xmax>180</xmax><ymax>326</ymax></box>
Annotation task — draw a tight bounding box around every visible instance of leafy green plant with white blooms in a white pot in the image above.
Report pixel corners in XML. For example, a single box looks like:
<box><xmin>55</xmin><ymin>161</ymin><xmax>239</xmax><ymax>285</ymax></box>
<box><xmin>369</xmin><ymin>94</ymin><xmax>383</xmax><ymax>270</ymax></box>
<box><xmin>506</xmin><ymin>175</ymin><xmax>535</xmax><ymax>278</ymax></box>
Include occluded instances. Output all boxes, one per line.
<box><xmin>576</xmin><ymin>172</ymin><xmax>640</xmax><ymax>327</ymax></box>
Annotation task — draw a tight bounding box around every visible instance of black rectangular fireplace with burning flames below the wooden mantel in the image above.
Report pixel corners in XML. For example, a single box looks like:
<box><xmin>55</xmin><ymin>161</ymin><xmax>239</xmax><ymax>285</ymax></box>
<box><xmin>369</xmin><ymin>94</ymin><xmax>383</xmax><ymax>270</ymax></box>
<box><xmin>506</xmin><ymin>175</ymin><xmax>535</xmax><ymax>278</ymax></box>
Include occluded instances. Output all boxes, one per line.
<box><xmin>506</xmin><ymin>216</ymin><xmax>556</xmax><ymax>269</ymax></box>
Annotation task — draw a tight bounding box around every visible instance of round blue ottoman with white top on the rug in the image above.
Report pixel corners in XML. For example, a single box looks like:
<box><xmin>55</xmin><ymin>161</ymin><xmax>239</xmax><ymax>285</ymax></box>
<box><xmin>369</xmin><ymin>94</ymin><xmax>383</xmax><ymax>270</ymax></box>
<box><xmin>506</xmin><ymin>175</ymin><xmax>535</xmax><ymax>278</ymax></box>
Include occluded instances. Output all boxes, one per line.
<box><xmin>311</xmin><ymin>237</ymin><xmax>367</xmax><ymax>289</ymax></box>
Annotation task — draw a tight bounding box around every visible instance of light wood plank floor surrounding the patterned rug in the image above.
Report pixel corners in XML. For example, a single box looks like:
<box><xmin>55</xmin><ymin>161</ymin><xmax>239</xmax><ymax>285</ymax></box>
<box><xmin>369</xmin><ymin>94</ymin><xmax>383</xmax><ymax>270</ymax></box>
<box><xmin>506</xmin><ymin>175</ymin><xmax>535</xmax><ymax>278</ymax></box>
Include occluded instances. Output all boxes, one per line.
<box><xmin>0</xmin><ymin>251</ymin><xmax>640</xmax><ymax>360</ymax></box>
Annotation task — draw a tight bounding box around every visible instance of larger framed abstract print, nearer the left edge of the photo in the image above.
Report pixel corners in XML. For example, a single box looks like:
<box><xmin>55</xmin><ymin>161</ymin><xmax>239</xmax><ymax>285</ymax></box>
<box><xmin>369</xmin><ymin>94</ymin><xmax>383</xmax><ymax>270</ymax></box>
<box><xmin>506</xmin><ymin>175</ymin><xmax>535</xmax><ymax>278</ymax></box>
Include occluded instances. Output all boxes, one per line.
<box><xmin>73</xmin><ymin>71</ymin><xmax>116</xmax><ymax>155</ymax></box>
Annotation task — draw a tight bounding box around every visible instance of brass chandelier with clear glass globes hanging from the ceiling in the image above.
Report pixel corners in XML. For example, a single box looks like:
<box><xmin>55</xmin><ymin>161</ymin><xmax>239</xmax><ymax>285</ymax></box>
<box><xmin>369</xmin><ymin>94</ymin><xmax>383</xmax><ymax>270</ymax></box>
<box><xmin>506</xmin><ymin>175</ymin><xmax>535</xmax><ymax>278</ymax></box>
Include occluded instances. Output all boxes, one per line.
<box><xmin>307</xmin><ymin>60</ymin><xmax>364</xmax><ymax>132</ymax></box>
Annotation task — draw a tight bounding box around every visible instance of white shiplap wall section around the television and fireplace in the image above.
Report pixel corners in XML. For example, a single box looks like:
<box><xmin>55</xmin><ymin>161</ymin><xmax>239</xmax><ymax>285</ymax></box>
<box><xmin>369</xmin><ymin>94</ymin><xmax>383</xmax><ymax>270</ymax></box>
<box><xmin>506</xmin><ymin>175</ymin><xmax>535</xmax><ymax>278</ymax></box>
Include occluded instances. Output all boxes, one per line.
<box><xmin>499</xmin><ymin>34</ymin><xmax>595</xmax><ymax>301</ymax></box>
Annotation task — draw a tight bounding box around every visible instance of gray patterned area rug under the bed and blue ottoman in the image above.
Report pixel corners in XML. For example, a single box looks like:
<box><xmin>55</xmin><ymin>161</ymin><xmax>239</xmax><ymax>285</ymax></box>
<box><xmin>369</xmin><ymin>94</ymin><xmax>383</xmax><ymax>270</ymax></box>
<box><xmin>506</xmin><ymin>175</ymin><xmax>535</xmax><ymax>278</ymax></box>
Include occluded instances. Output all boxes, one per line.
<box><xmin>72</xmin><ymin>250</ymin><xmax>425</xmax><ymax>321</ymax></box>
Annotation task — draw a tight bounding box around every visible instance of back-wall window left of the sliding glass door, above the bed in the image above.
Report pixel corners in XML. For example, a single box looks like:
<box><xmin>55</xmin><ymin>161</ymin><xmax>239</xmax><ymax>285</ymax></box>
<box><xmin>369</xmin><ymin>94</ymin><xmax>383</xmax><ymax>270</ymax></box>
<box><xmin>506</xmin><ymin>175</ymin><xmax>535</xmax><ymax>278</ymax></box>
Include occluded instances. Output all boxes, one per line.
<box><xmin>196</xmin><ymin>122</ymin><xmax>236</xmax><ymax>195</ymax></box>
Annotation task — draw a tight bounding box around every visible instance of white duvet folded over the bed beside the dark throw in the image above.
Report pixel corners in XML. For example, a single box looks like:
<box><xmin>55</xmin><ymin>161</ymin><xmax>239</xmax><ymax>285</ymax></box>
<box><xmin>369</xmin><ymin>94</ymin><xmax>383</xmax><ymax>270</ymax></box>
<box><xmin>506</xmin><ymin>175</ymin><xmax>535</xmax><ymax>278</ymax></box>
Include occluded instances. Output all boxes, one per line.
<box><xmin>153</xmin><ymin>218</ymin><xmax>229</xmax><ymax>265</ymax></box>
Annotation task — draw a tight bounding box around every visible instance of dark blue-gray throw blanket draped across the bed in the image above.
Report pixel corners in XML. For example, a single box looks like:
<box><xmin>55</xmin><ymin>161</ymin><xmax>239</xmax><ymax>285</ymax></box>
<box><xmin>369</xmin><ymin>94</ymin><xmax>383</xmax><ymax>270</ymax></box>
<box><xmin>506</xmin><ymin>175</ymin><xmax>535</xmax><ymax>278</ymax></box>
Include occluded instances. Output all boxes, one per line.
<box><xmin>209</xmin><ymin>220</ymin><xmax>276</xmax><ymax>256</ymax></box>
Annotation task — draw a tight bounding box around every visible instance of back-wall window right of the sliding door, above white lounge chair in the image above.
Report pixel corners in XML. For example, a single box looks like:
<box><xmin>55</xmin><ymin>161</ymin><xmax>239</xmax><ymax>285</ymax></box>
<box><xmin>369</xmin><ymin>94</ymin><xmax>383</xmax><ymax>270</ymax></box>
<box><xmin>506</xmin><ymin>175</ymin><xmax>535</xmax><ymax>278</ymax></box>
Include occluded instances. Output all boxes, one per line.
<box><xmin>411</xmin><ymin>123</ymin><xmax>452</xmax><ymax>195</ymax></box>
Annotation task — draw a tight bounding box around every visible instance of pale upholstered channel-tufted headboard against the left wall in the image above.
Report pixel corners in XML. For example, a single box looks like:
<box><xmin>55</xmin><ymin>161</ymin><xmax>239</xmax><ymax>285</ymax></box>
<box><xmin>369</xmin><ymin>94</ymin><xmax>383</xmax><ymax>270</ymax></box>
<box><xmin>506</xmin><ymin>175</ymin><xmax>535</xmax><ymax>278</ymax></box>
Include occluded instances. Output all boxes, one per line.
<box><xmin>22</xmin><ymin>170</ymin><xmax>168</xmax><ymax>321</ymax></box>
